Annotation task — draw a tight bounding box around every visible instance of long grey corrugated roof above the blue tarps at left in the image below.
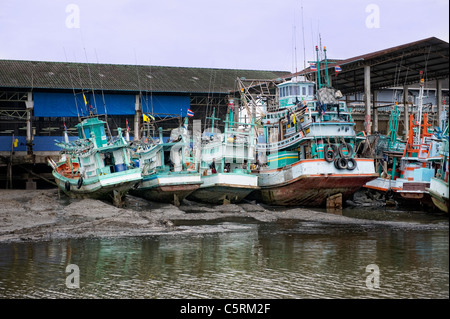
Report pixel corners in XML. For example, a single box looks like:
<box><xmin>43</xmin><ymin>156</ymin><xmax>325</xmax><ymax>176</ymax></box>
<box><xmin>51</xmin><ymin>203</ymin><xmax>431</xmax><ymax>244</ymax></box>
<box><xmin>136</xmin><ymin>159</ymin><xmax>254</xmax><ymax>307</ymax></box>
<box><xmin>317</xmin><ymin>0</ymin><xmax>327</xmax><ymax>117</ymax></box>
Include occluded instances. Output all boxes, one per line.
<box><xmin>0</xmin><ymin>60</ymin><xmax>290</xmax><ymax>93</ymax></box>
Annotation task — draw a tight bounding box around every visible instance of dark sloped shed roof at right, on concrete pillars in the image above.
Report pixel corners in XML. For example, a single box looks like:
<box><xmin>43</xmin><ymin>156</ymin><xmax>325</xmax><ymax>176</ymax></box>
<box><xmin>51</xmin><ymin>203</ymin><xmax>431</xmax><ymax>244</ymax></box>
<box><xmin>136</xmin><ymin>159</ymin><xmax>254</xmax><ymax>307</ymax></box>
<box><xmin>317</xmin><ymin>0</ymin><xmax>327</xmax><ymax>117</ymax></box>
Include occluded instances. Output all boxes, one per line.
<box><xmin>287</xmin><ymin>37</ymin><xmax>449</xmax><ymax>94</ymax></box>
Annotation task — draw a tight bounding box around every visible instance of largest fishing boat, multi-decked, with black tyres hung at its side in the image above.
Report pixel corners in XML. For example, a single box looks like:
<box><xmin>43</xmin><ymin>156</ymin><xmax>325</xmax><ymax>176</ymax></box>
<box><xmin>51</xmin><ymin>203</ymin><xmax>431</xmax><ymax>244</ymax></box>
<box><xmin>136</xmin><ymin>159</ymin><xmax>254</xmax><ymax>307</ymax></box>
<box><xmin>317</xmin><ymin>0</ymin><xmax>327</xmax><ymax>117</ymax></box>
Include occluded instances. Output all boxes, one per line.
<box><xmin>253</xmin><ymin>47</ymin><xmax>377</xmax><ymax>207</ymax></box>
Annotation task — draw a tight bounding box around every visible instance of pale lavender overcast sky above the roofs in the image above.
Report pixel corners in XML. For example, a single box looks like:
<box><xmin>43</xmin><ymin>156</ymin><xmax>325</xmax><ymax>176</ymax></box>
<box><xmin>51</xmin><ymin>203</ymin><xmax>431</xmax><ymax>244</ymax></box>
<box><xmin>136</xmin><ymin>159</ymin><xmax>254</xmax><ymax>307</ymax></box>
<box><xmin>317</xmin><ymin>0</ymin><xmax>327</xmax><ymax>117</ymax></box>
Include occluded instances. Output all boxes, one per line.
<box><xmin>0</xmin><ymin>0</ymin><xmax>449</xmax><ymax>71</ymax></box>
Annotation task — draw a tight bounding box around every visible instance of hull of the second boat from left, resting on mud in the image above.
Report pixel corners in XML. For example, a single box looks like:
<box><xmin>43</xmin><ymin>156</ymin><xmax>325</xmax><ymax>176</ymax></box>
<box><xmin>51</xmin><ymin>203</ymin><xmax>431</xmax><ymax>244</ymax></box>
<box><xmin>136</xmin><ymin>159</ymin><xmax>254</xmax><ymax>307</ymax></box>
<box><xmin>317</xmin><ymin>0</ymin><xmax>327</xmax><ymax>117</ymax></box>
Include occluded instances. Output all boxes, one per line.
<box><xmin>131</xmin><ymin>173</ymin><xmax>202</xmax><ymax>206</ymax></box>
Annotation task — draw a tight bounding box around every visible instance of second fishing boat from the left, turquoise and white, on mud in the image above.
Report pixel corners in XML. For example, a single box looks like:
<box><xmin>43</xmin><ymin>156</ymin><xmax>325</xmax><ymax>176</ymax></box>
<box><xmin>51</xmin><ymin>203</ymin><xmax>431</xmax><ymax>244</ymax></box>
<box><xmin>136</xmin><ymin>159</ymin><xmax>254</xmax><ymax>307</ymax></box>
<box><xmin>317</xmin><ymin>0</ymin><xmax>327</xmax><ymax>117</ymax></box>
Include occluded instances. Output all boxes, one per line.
<box><xmin>131</xmin><ymin>118</ymin><xmax>202</xmax><ymax>206</ymax></box>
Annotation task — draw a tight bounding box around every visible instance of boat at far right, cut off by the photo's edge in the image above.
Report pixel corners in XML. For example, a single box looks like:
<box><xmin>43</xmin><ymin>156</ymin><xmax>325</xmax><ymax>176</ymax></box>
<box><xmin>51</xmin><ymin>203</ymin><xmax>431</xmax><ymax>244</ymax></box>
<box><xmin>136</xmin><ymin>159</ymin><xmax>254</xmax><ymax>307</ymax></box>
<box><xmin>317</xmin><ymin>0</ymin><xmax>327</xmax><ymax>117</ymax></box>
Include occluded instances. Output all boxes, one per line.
<box><xmin>426</xmin><ymin>124</ymin><xmax>449</xmax><ymax>213</ymax></box>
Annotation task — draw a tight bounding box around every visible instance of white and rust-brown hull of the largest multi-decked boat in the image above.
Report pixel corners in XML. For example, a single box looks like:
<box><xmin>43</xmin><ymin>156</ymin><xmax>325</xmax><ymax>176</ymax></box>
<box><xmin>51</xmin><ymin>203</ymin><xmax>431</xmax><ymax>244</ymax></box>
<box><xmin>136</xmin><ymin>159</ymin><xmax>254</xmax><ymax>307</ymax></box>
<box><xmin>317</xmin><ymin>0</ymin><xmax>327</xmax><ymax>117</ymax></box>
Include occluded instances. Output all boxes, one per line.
<box><xmin>255</xmin><ymin>159</ymin><xmax>377</xmax><ymax>207</ymax></box>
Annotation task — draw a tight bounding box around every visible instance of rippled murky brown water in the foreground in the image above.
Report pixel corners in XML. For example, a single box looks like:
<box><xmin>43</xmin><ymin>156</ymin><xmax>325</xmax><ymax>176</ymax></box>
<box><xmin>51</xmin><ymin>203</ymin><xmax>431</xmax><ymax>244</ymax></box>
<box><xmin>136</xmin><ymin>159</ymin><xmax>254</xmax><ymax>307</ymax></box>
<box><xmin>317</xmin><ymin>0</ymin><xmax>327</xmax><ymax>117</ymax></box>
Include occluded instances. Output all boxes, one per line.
<box><xmin>0</xmin><ymin>209</ymin><xmax>449</xmax><ymax>298</ymax></box>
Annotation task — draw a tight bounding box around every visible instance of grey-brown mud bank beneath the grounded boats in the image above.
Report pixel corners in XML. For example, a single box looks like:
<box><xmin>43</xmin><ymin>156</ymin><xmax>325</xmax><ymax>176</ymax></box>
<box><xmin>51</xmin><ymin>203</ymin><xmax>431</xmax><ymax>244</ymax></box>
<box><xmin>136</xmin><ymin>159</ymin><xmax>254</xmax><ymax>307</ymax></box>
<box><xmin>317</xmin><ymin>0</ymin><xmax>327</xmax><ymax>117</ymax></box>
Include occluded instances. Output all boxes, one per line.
<box><xmin>0</xmin><ymin>189</ymin><xmax>448</xmax><ymax>242</ymax></box>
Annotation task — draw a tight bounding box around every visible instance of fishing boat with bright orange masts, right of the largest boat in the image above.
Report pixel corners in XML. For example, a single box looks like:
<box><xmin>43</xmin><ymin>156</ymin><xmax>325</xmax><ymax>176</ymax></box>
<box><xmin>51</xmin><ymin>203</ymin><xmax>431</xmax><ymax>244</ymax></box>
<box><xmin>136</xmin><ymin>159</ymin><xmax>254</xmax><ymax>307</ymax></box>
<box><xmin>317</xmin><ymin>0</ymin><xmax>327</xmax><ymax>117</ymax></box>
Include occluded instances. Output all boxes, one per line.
<box><xmin>364</xmin><ymin>73</ymin><xmax>442</xmax><ymax>209</ymax></box>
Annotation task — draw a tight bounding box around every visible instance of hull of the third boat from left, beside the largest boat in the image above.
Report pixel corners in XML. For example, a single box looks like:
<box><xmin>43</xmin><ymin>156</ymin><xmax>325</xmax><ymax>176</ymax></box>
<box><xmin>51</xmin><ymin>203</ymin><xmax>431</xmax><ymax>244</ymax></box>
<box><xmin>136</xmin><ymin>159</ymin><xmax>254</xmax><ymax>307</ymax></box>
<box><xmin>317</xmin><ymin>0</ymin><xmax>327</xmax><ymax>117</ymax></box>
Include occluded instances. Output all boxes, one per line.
<box><xmin>188</xmin><ymin>173</ymin><xmax>259</xmax><ymax>205</ymax></box>
